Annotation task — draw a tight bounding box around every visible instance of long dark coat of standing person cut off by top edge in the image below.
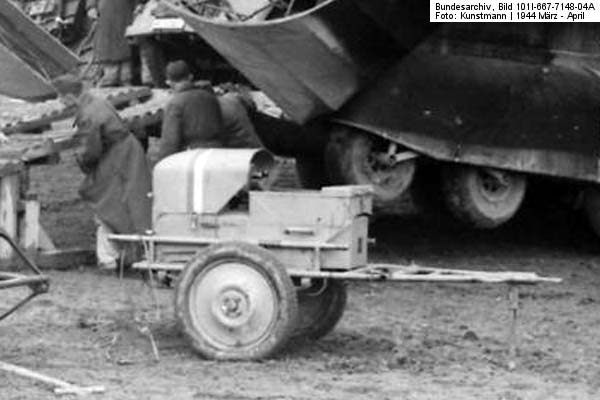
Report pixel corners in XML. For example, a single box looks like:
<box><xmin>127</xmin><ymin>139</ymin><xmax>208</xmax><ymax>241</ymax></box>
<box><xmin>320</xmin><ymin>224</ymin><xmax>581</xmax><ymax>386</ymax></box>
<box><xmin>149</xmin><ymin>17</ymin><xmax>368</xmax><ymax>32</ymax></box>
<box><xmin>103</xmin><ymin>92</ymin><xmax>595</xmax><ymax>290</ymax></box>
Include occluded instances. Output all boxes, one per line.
<box><xmin>94</xmin><ymin>0</ymin><xmax>137</xmax><ymax>63</ymax></box>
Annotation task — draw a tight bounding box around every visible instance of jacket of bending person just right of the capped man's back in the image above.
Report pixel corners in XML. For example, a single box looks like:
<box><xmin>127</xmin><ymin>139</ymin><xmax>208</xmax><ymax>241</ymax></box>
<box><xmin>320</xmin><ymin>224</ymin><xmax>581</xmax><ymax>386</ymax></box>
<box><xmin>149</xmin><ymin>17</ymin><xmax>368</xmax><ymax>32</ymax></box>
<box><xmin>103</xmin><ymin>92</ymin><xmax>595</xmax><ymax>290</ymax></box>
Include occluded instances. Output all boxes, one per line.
<box><xmin>219</xmin><ymin>93</ymin><xmax>263</xmax><ymax>148</ymax></box>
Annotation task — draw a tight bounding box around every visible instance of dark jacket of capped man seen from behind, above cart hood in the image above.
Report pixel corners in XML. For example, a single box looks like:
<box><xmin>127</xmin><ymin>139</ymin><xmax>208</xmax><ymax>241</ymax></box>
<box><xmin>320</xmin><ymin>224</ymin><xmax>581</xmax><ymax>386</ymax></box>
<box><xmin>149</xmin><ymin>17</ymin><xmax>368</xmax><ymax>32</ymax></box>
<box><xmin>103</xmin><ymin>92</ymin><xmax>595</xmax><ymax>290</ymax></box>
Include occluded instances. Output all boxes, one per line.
<box><xmin>158</xmin><ymin>83</ymin><xmax>223</xmax><ymax>160</ymax></box>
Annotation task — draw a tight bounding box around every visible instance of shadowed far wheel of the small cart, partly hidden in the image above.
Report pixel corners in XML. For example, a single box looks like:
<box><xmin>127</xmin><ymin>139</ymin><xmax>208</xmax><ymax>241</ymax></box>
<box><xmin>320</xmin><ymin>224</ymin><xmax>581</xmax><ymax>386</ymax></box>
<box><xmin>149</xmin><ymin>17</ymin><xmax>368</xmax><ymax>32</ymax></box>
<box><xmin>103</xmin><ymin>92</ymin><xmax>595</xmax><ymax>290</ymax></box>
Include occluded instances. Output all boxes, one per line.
<box><xmin>294</xmin><ymin>279</ymin><xmax>348</xmax><ymax>340</ymax></box>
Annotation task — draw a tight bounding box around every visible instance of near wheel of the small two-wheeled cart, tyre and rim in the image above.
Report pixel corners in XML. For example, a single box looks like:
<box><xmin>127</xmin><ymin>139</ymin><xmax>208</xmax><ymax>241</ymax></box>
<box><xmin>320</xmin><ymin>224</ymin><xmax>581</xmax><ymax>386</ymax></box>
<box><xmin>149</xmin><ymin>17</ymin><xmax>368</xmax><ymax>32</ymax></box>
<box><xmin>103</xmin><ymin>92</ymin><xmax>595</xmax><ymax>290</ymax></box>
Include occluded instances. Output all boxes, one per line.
<box><xmin>175</xmin><ymin>242</ymin><xmax>298</xmax><ymax>360</ymax></box>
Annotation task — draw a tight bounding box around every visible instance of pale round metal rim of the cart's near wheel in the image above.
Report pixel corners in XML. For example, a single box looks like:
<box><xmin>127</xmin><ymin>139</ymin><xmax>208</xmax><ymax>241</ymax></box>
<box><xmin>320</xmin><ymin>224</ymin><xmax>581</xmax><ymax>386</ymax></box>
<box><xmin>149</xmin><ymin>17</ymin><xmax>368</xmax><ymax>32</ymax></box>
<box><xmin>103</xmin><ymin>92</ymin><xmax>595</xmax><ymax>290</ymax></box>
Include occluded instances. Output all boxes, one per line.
<box><xmin>189</xmin><ymin>261</ymin><xmax>278</xmax><ymax>349</ymax></box>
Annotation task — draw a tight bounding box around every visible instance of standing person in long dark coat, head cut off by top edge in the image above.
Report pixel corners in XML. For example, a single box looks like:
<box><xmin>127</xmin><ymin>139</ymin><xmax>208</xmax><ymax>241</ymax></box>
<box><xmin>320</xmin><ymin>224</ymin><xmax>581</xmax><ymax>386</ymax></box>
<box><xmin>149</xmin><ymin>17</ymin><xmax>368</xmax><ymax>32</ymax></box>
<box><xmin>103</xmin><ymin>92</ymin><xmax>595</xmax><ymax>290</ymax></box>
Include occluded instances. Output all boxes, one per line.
<box><xmin>88</xmin><ymin>0</ymin><xmax>138</xmax><ymax>86</ymax></box>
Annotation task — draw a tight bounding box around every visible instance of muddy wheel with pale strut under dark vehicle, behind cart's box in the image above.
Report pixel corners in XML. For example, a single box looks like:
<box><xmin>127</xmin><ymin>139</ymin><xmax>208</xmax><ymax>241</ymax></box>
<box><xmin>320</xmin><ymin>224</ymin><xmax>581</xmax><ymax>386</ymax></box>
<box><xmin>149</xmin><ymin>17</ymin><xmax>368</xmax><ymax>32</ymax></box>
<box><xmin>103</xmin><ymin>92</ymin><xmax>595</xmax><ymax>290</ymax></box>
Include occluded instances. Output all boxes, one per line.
<box><xmin>325</xmin><ymin>126</ymin><xmax>415</xmax><ymax>207</ymax></box>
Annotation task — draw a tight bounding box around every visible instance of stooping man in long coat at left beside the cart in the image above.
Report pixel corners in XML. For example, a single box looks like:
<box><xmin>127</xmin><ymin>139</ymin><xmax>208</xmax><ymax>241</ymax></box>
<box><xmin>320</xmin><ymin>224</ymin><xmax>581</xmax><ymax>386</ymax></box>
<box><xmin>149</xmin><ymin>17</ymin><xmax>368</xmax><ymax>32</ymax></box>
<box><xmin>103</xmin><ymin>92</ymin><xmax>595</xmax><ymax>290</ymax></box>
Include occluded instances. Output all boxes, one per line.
<box><xmin>53</xmin><ymin>75</ymin><xmax>151</xmax><ymax>269</ymax></box>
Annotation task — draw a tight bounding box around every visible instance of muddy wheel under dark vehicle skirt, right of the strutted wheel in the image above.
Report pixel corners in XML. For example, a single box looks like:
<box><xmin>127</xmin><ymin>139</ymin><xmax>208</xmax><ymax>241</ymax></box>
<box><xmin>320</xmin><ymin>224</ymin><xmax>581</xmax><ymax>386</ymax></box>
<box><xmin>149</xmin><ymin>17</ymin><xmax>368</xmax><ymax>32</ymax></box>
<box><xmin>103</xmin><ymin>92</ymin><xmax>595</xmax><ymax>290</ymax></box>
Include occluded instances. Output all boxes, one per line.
<box><xmin>442</xmin><ymin>166</ymin><xmax>527</xmax><ymax>229</ymax></box>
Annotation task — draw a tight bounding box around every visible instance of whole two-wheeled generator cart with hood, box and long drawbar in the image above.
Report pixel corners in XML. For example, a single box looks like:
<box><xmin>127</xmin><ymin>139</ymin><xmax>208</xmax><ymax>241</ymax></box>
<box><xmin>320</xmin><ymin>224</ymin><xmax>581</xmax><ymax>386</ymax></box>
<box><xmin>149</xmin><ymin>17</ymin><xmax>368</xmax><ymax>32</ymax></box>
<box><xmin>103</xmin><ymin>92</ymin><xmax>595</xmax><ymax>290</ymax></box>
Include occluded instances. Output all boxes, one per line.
<box><xmin>111</xmin><ymin>149</ymin><xmax>560</xmax><ymax>359</ymax></box>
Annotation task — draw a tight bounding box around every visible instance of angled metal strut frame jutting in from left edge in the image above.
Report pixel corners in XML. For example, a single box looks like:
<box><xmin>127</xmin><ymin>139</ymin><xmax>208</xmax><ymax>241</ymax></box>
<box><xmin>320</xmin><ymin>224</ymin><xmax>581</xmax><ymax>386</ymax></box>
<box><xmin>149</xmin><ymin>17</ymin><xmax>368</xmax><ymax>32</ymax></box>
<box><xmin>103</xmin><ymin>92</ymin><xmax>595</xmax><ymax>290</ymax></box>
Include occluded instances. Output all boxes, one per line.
<box><xmin>0</xmin><ymin>229</ymin><xmax>50</xmax><ymax>321</ymax></box>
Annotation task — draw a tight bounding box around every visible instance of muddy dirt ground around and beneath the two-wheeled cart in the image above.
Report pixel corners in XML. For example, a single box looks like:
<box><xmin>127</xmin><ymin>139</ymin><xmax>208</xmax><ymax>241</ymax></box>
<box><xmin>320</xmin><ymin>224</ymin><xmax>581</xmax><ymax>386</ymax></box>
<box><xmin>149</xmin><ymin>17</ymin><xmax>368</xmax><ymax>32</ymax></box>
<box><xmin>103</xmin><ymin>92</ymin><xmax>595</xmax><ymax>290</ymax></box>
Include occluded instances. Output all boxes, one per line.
<box><xmin>0</xmin><ymin>151</ymin><xmax>600</xmax><ymax>400</ymax></box>
